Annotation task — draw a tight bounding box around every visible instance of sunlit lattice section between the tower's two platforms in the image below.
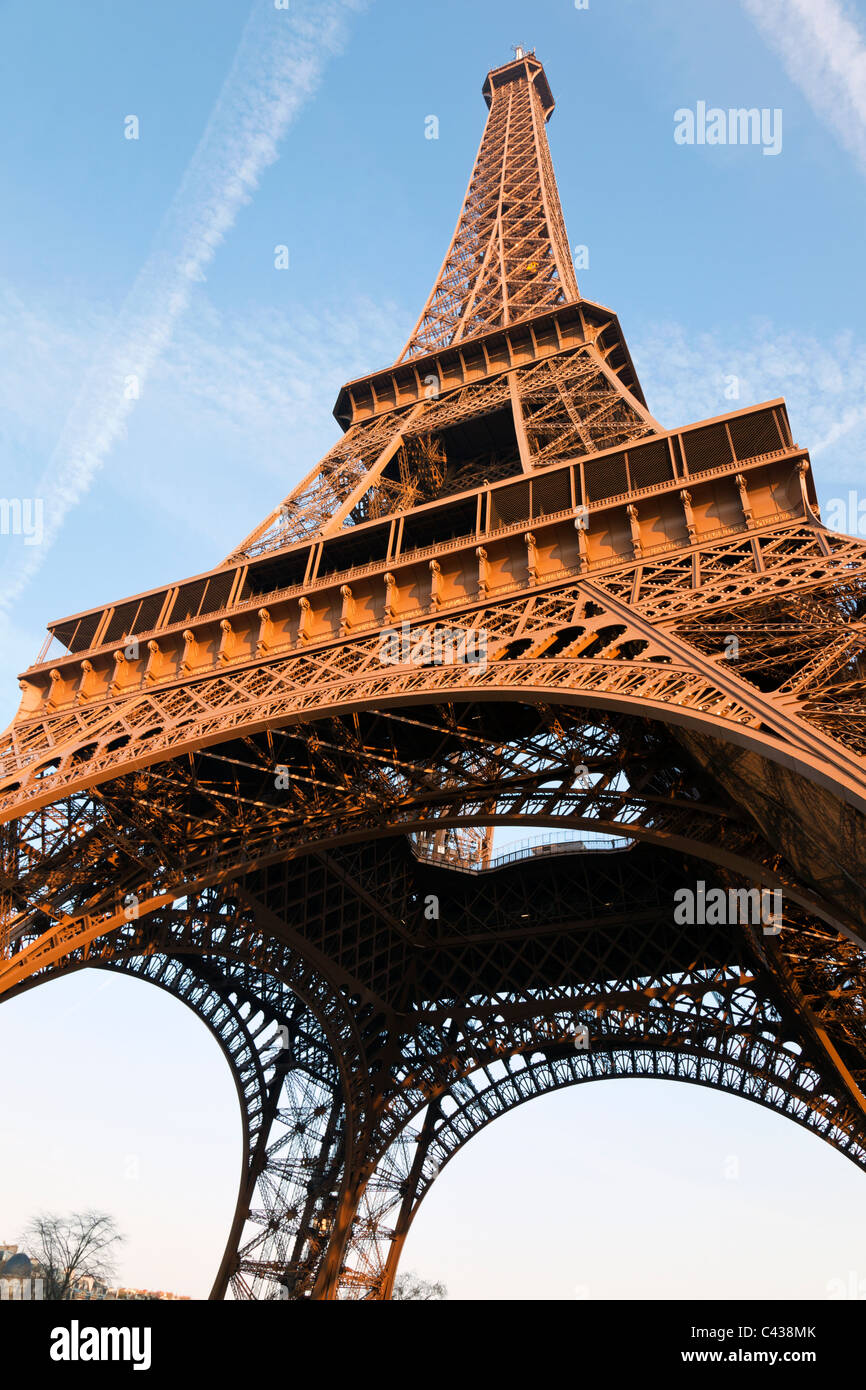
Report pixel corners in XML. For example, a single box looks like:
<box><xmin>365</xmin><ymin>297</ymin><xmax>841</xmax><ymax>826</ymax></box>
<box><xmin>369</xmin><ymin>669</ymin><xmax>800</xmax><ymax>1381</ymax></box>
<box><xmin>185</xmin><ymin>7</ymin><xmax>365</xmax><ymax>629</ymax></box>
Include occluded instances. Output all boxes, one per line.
<box><xmin>223</xmin><ymin>328</ymin><xmax>657</xmax><ymax>562</ymax></box>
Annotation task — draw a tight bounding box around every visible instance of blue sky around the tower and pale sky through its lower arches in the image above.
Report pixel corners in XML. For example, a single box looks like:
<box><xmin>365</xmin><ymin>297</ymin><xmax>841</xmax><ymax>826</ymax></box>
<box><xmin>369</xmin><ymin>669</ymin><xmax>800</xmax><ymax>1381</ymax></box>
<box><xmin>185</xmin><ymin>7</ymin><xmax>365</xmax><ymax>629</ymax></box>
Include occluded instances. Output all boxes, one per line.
<box><xmin>0</xmin><ymin>0</ymin><xmax>866</xmax><ymax>1298</ymax></box>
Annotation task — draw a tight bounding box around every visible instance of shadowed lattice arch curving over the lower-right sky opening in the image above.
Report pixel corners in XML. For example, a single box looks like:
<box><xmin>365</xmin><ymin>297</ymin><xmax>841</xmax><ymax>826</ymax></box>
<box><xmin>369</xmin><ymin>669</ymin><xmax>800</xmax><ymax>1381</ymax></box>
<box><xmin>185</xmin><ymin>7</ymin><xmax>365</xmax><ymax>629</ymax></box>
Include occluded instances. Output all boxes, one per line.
<box><xmin>301</xmin><ymin>839</ymin><xmax>866</xmax><ymax>1297</ymax></box>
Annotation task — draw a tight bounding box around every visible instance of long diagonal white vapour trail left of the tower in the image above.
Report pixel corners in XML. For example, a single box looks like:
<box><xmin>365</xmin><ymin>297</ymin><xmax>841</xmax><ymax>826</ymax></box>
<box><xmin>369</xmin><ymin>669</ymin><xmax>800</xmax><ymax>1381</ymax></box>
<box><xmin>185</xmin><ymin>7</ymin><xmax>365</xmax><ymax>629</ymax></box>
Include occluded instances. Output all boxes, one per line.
<box><xmin>0</xmin><ymin>0</ymin><xmax>360</xmax><ymax>609</ymax></box>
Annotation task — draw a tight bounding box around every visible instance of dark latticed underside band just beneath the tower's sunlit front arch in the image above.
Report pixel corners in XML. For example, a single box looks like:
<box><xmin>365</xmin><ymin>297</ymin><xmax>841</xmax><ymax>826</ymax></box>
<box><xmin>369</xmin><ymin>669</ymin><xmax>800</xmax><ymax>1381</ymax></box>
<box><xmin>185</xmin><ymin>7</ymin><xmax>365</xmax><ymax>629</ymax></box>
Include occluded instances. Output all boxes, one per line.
<box><xmin>0</xmin><ymin>675</ymin><xmax>866</xmax><ymax>987</ymax></box>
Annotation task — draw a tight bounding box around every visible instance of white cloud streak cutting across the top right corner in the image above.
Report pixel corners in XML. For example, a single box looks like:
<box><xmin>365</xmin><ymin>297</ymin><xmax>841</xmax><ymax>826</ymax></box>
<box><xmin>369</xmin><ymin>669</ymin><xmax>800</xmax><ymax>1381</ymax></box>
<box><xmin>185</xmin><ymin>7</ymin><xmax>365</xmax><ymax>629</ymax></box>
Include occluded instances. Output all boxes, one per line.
<box><xmin>742</xmin><ymin>0</ymin><xmax>866</xmax><ymax>174</ymax></box>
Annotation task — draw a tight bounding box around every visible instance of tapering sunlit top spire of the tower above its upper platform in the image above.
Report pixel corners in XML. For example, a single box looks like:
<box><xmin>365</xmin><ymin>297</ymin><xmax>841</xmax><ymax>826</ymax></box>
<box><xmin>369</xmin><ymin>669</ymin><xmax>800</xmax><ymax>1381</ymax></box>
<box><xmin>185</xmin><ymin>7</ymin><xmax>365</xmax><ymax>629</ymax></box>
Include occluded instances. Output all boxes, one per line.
<box><xmin>398</xmin><ymin>44</ymin><xmax>578</xmax><ymax>361</ymax></box>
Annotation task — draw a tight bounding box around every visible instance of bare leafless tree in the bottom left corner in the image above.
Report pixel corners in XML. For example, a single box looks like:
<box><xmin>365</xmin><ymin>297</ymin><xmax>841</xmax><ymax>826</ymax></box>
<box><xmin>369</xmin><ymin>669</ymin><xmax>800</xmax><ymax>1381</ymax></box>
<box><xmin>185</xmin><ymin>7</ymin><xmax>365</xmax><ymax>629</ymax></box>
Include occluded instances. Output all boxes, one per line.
<box><xmin>19</xmin><ymin>1211</ymin><xmax>124</xmax><ymax>1302</ymax></box>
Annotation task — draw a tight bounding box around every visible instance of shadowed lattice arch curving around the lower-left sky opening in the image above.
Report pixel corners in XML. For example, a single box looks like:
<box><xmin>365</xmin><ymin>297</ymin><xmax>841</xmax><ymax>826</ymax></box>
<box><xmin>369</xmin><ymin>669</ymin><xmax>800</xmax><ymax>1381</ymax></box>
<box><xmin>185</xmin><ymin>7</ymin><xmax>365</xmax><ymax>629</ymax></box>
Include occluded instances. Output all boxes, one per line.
<box><xmin>1</xmin><ymin>899</ymin><xmax>368</xmax><ymax>1298</ymax></box>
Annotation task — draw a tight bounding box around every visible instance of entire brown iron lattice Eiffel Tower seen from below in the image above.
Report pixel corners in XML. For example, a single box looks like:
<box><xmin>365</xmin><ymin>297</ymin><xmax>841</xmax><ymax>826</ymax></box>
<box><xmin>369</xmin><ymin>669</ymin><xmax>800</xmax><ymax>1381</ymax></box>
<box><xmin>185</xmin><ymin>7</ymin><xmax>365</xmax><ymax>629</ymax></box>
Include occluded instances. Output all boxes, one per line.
<box><xmin>0</xmin><ymin>50</ymin><xmax>866</xmax><ymax>1298</ymax></box>
